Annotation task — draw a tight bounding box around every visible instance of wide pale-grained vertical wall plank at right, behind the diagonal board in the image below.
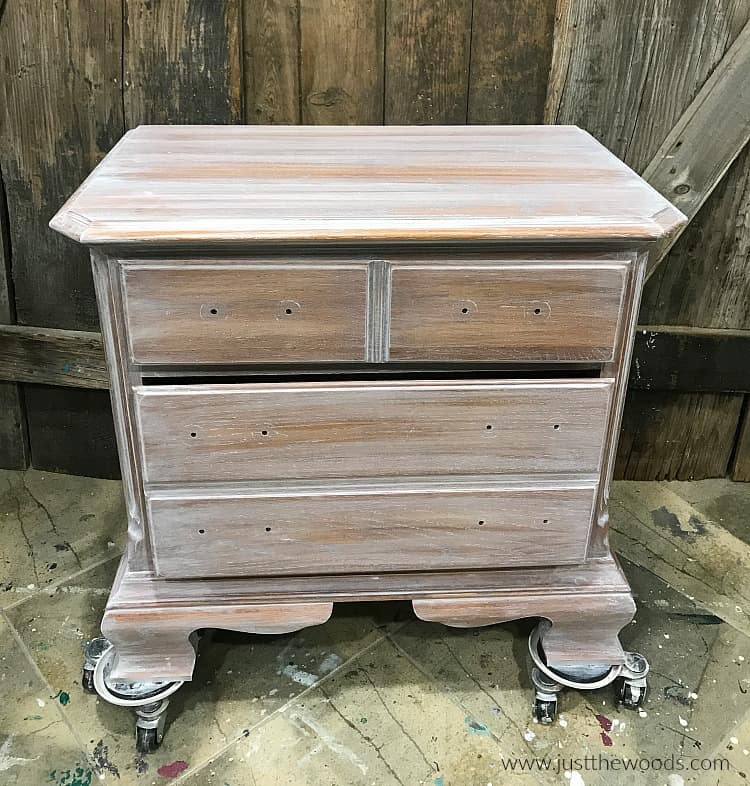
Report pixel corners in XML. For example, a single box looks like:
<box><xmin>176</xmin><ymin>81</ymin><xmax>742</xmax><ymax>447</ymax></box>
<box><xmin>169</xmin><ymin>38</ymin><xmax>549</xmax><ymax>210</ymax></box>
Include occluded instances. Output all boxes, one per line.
<box><xmin>545</xmin><ymin>0</ymin><xmax>750</xmax><ymax>479</ymax></box>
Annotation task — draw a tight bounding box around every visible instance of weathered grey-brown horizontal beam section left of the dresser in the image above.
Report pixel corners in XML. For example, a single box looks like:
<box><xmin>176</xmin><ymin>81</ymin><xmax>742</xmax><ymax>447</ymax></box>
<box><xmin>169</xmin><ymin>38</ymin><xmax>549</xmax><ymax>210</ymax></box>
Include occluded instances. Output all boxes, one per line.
<box><xmin>0</xmin><ymin>325</ymin><xmax>109</xmax><ymax>389</ymax></box>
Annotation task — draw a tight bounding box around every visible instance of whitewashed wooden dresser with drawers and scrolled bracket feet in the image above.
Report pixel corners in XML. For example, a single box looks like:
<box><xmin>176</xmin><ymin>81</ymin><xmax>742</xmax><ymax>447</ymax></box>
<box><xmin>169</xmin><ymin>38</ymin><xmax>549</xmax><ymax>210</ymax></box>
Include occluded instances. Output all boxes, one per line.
<box><xmin>51</xmin><ymin>126</ymin><xmax>685</xmax><ymax>744</ymax></box>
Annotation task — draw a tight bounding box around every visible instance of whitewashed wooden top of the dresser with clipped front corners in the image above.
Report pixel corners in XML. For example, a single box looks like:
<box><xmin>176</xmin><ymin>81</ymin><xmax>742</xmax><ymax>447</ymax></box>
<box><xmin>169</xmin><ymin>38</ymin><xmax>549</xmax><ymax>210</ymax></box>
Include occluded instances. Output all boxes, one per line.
<box><xmin>50</xmin><ymin>126</ymin><xmax>685</xmax><ymax>244</ymax></box>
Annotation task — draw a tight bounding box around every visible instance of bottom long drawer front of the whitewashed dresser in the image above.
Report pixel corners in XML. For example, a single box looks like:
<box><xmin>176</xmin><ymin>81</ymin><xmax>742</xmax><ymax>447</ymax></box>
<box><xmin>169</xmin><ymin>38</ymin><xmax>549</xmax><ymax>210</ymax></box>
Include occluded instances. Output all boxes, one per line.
<box><xmin>149</xmin><ymin>478</ymin><xmax>596</xmax><ymax>578</ymax></box>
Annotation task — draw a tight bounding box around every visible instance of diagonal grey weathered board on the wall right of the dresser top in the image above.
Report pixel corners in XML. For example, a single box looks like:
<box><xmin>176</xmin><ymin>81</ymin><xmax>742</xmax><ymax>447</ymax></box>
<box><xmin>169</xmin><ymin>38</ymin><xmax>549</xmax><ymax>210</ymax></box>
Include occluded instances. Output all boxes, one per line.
<box><xmin>642</xmin><ymin>15</ymin><xmax>750</xmax><ymax>277</ymax></box>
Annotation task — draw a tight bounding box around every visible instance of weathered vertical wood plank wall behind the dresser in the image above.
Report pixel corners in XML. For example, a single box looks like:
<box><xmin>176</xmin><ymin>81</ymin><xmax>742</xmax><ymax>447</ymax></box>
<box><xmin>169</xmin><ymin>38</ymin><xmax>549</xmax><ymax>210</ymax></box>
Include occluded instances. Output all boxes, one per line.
<box><xmin>0</xmin><ymin>0</ymin><xmax>750</xmax><ymax>478</ymax></box>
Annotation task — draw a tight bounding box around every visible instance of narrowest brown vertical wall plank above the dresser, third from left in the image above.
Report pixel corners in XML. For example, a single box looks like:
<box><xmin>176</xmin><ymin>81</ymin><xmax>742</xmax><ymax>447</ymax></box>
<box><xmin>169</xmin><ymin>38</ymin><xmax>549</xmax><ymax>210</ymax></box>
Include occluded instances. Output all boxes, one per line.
<box><xmin>242</xmin><ymin>0</ymin><xmax>300</xmax><ymax>125</ymax></box>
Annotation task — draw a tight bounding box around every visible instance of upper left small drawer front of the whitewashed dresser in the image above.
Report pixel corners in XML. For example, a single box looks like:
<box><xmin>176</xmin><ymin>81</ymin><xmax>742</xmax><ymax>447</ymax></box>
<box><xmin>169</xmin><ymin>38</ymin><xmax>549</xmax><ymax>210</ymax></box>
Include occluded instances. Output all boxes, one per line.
<box><xmin>122</xmin><ymin>264</ymin><xmax>367</xmax><ymax>364</ymax></box>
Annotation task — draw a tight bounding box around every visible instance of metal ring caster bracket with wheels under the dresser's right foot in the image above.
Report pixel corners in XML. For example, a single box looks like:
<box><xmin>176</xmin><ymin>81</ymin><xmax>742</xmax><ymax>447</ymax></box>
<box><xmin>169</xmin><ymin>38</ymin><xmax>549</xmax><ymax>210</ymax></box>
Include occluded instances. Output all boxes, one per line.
<box><xmin>529</xmin><ymin>623</ymin><xmax>649</xmax><ymax>724</ymax></box>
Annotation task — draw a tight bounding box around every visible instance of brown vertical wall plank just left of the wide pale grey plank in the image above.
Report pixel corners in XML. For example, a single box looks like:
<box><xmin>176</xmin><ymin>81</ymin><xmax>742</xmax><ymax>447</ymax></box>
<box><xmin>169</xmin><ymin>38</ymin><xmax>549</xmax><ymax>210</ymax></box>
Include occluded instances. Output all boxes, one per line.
<box><xmin>468</xmin><ymin>0</ymin><xmax>555</xmax><ymax>124</ymax></box>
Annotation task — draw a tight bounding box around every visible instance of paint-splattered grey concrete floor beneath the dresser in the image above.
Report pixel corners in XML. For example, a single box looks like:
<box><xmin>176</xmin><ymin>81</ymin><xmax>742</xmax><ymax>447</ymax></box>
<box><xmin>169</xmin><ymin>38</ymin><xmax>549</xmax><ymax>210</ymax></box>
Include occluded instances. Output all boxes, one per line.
<box><xmin>0</xmin><ymin>471</ymin><xmax>750</xmax><ymax>786</ymax></box>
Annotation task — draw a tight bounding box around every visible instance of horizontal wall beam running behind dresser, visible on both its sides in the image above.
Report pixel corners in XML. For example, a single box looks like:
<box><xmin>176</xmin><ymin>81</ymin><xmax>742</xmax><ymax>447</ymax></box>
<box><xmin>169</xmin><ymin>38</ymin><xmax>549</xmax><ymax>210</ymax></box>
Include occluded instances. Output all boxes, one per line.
<box><xmin>0</xmin><ymin>325</ymin><xmax>750</xmax><ymax>393</ymax></box>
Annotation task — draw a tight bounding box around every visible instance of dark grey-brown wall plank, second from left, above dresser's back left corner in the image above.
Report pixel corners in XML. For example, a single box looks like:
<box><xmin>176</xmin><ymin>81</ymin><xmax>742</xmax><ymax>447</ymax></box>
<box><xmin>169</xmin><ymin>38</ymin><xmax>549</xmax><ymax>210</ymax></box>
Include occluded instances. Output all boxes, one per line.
<box><xmin>123</xmin><ymin>0</ymin><xmax>243</xmax><ymax>128</ymax></box>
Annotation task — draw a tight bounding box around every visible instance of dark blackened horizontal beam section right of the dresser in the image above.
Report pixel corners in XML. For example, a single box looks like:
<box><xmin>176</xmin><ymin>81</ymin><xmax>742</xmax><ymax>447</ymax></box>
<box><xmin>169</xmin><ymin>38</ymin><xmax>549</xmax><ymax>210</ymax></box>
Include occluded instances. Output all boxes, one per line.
<box><xmin>629</xmin><ymin>325</ymin><xmax>750</xmax><ymax>393</ymax></box>
